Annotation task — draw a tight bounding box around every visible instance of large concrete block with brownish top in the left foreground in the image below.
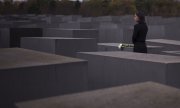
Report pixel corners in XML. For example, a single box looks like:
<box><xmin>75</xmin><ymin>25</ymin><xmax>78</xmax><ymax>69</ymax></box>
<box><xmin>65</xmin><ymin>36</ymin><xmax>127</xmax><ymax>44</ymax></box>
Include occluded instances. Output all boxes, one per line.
<box><xmin>0</xmin><ymin>48</ymin><xmax>87</xmax><ymax>108</ymax></box>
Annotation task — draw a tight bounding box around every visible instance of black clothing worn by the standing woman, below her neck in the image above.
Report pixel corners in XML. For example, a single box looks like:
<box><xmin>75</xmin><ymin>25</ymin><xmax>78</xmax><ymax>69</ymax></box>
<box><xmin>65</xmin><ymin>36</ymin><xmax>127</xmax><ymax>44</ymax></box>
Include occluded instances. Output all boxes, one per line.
<box><xmin>132</xmin><ymin>22</ymin><xmax>148</xmax><ymax>53</ymax></box>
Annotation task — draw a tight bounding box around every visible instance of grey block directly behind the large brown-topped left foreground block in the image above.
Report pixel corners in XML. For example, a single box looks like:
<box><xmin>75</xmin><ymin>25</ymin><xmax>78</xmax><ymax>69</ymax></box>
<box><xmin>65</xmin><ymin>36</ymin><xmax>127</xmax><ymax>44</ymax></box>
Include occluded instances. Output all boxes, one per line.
<box><xmin>21</xmin><ymin>37</ymin><xmax>97</xmax><ymax>57</ymax></box>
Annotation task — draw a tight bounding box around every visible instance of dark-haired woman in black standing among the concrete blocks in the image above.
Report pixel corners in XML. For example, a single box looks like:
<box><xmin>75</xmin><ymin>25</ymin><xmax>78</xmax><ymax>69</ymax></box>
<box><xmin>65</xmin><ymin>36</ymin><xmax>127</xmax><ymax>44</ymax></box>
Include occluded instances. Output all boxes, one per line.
<box><xmin>132</xmin><ymin>12</ymin><xmax>148</xmax><ymax>53</ymax></box>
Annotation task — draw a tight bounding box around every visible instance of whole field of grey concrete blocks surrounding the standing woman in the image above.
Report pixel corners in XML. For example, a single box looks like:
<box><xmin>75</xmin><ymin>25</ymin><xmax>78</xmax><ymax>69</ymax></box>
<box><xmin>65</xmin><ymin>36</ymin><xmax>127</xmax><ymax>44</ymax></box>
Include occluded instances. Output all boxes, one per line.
<box><xmin>0</xmin><ymin>14</ymin><xmax>180</xmax><ymax>108</ymax></box>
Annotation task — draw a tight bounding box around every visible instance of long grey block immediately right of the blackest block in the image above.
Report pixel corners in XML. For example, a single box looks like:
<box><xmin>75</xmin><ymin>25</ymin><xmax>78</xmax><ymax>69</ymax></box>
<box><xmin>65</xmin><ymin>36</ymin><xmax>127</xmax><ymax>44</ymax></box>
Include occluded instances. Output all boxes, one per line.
<box><xmin>43</xmin><ymin>28</ymin><xmax>99</xmax><ymax>40</ymax></box>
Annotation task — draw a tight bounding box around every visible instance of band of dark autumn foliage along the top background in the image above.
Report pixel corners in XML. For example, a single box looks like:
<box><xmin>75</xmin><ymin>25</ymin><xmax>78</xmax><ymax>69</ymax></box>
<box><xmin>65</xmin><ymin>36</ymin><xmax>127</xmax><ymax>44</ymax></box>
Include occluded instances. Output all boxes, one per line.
<box><xmin>0</xmin><ymin>0</ymin><xmax>180</xmax><ymax>16</ymax></box>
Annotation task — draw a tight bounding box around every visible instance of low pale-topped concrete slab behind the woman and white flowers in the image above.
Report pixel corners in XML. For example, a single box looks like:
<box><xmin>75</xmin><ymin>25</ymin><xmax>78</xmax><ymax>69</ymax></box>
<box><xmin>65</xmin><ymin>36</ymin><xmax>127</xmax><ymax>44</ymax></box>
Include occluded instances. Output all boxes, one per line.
<box><xmin>98</xmin><ymin>43</ymin><xmax>163</xmax><ymax>54</ymax></box>
